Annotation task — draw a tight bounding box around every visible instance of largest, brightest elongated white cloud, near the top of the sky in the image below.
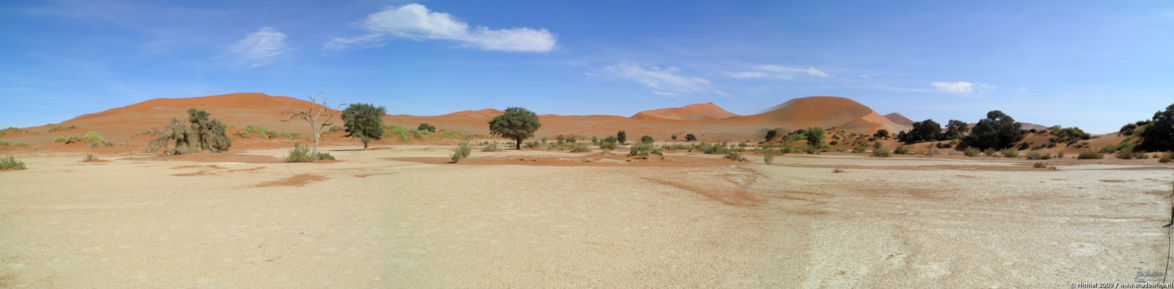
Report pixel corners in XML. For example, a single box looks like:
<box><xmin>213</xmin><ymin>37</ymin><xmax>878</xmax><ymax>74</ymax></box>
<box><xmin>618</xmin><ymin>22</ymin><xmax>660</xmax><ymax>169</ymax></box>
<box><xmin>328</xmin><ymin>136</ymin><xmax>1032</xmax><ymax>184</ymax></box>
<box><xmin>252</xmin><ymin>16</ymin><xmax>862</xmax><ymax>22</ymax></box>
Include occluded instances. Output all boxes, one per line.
<box><xmin>325</xmin><ymin>4</ymin><xmax>555</xmax><ymax>52</ymax></box>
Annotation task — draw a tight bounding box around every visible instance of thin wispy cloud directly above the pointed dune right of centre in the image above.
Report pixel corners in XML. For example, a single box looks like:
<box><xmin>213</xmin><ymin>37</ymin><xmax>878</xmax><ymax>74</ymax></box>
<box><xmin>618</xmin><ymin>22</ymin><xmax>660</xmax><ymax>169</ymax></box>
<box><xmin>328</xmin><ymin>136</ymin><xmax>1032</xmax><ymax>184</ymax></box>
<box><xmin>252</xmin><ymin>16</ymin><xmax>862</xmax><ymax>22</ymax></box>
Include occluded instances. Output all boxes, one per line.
<box><xmin>603</xmin><ymin>62</ymin><xmax>726</xmax><ymax>96</ymax></box>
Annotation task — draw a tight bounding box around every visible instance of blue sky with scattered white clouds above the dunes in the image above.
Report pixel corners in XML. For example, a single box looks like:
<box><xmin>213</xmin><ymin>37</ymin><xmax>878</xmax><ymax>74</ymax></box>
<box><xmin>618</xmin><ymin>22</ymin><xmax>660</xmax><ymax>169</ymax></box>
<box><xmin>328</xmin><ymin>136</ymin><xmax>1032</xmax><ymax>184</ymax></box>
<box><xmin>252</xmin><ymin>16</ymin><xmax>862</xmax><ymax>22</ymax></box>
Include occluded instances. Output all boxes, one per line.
<box><xmin>0</xmin><ymin>0</ymin><xmax>1174</xmax><ymax>133</ymax></box>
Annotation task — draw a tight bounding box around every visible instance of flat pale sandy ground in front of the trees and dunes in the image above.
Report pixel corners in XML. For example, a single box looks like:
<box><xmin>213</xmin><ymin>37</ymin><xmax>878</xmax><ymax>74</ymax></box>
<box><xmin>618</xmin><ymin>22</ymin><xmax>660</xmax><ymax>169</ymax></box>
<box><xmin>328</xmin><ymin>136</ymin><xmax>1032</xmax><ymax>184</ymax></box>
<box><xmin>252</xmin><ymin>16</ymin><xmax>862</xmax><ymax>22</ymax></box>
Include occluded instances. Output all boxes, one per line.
<box><xmin>0</xmin><ymin>146</ymin><xmax>1174</xmax><ymax>288</ymax></box>
